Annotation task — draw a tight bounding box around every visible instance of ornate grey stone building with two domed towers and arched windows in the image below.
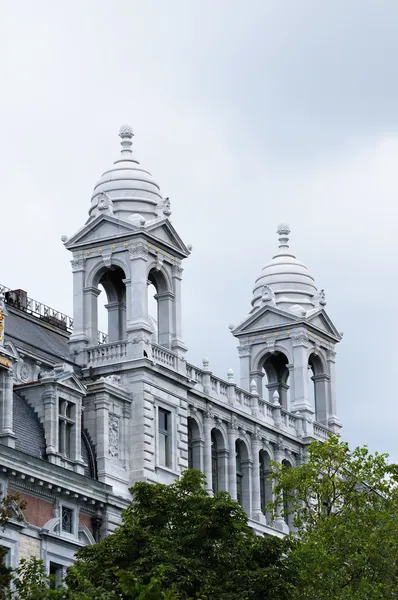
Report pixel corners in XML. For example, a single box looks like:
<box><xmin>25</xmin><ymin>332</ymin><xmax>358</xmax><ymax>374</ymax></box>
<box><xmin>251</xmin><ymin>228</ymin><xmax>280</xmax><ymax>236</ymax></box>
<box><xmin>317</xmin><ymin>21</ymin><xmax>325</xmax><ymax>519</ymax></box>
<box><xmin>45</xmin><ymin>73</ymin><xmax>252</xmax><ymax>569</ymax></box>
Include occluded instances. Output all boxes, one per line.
<box><xmin>0</xmin><ymin>126</ymin><xmax>341</xmax><ymax>577</ymax></box>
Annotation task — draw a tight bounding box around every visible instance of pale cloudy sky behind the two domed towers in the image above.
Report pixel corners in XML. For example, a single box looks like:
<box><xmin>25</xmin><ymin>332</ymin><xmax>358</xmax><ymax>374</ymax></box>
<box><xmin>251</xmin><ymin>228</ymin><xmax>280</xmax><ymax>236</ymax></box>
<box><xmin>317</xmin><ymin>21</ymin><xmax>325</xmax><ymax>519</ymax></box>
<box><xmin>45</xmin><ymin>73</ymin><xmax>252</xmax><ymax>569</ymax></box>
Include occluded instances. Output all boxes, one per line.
<box><xmin>0</xmin><ymin>0</ymin><xmax>398</xmax><ymax>460</ymax></box>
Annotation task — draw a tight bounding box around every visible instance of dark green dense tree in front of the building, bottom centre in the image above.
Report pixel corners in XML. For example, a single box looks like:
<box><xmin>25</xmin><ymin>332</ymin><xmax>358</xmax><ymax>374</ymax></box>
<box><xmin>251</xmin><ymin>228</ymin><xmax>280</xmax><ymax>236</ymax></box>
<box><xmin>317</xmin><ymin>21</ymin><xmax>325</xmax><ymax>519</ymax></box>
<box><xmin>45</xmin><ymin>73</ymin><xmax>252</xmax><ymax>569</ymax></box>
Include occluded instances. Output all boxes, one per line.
<box><xmin>66</xmin><ymin>470</ymin><xmax>294</xmax><ymax>600</ymax></box>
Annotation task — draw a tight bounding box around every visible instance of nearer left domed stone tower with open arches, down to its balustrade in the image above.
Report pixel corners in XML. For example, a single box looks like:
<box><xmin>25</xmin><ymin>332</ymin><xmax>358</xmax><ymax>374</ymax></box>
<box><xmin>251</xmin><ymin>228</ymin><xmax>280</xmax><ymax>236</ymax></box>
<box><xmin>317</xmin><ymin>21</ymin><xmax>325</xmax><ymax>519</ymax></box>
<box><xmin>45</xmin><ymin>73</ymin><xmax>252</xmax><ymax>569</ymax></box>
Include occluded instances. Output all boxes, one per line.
<box><xmin>63</xmin><ymin>125</ymin><xmax>189</xmax><ymax>366</ymax></box>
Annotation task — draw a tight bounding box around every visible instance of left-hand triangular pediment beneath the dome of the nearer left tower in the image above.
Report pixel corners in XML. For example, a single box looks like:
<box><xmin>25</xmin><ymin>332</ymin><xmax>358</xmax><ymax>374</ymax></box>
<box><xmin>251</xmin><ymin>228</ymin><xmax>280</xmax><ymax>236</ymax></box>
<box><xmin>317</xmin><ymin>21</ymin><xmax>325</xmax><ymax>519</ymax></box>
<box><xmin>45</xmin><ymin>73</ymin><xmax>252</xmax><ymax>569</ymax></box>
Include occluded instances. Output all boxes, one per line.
<box><xmin>65</xmin><ymin>215</ymin><xmax>139</xmax><ymax>249</ymax></box>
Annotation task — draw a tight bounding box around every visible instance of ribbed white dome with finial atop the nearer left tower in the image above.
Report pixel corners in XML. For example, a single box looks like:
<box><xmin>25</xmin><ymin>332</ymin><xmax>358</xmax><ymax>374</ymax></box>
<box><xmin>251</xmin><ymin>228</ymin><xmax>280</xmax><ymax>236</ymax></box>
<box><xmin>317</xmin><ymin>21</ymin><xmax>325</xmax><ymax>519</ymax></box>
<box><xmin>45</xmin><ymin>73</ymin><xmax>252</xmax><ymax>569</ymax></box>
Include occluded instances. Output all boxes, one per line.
<box><xmin>88</xmin><ymin>125</ymin><xmax>164</xmax><ymax>222</ymax></box>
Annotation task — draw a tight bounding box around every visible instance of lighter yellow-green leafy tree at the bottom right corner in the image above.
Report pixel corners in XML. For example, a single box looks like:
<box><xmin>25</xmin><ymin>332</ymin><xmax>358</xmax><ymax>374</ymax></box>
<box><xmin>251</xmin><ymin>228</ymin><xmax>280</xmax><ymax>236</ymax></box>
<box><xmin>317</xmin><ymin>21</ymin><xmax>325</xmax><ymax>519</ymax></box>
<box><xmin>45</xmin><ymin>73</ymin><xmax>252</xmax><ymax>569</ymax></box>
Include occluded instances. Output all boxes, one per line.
<box><xmin>271</xmin><ymin>435</ymin><xmax>398</xmax><ymax>600</ymax></box>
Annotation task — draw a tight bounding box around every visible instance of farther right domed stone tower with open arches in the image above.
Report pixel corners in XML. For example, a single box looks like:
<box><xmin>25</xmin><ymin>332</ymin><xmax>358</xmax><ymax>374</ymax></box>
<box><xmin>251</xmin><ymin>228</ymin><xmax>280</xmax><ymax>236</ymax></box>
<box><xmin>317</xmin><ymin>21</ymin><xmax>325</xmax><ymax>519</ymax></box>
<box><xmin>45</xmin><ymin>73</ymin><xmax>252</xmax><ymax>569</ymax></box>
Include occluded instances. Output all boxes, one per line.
<box><xmin>232</xmin><ymin>223</ymin><xmax>341</xmax><ymax>430</ymax></box>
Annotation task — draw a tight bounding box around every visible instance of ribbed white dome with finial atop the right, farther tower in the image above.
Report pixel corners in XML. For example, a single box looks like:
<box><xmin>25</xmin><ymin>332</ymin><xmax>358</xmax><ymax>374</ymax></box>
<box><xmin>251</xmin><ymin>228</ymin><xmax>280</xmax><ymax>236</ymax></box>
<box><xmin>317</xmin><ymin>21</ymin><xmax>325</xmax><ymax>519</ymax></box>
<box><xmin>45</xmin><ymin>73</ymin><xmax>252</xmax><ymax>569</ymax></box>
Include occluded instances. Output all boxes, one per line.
<box><xmin>252</xmin><ymin>223</ymin><xmax>317</xmax><ymax>314</ymax></box>
